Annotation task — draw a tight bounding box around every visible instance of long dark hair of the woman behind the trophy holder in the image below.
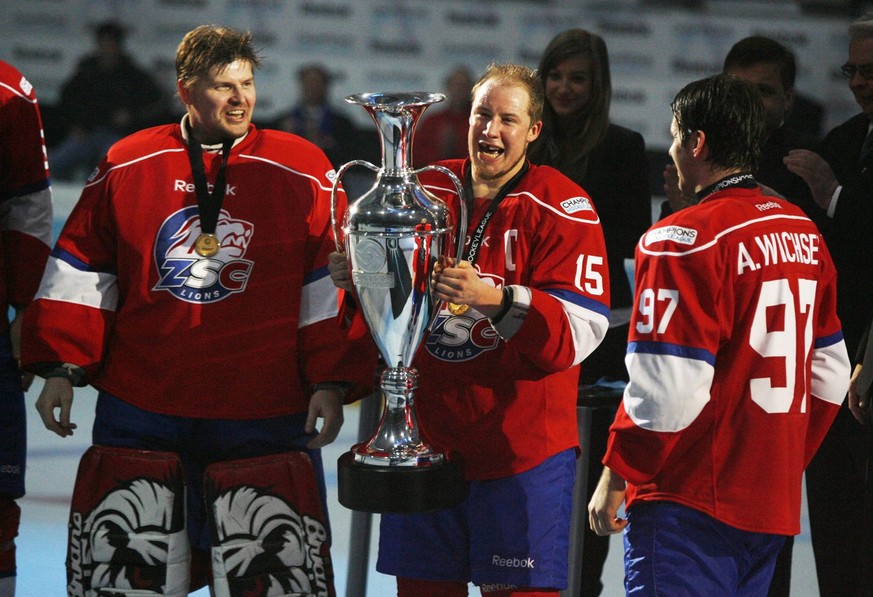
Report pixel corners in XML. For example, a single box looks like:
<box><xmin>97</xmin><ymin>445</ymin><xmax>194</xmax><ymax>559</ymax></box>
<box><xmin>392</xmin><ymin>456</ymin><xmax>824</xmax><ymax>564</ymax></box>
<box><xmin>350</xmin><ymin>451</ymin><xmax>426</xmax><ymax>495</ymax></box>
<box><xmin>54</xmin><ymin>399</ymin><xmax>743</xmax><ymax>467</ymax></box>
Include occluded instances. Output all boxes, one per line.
<box><xmin>528</xmin><ymin>29</ymin><xmax>612</xmax><ymax>180</ymax></box>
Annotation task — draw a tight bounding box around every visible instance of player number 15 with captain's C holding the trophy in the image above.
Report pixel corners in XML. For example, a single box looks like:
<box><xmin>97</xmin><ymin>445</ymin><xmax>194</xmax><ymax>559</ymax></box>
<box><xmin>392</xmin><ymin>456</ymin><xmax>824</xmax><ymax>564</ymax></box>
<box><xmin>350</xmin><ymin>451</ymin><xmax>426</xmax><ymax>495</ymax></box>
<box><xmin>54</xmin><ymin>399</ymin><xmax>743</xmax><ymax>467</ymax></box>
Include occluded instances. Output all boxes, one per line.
<box><xmin>331</xmin><ymin>65</ymin><xmax>609</xmax><ymax>597</ymax></box>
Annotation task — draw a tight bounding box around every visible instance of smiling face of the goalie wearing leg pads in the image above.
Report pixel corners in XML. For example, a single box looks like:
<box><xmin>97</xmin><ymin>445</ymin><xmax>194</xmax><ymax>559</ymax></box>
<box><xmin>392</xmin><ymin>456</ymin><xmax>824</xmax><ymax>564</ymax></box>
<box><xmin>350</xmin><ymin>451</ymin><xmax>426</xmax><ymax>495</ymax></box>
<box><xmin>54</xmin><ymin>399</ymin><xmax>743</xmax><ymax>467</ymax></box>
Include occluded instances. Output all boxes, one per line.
<box><xmin>179</xmin><ymin>60</ymin><xmax>255</xmax><ymax>145</ymax></box>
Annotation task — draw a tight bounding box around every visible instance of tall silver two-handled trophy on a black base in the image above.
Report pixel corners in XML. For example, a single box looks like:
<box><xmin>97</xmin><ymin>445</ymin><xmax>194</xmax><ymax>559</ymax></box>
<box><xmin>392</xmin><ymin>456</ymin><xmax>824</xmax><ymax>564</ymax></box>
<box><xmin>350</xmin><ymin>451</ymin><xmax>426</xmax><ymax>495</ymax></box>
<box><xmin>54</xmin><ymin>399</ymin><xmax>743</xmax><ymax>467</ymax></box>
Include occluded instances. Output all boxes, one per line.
<box><xmin>331</xmin><ymin>92</ymin><xmax>467</xmax><ymax>512</ymax></box>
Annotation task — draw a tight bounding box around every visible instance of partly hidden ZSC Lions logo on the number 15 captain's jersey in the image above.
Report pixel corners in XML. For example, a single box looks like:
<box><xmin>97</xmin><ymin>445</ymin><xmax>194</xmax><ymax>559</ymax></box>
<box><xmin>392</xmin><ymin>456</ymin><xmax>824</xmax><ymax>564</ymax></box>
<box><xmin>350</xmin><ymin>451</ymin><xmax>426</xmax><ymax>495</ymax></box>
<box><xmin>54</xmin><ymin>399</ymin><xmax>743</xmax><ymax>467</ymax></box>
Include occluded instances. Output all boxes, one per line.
<box><xmin>425</xmin><ymin>268</ymin><xmax>503</xmax><ymax>362</ymax></box>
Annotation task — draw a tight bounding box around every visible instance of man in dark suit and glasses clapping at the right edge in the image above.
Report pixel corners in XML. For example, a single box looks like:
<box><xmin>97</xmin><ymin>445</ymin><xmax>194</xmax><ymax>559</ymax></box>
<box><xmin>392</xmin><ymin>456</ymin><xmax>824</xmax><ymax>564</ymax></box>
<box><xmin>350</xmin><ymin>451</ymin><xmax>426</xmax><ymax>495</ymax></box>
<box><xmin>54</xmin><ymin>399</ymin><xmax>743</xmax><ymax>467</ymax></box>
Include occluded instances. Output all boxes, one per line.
<box><xmin>784</xmin><ymin>13</ymin><xmax>873</xmax><ymax>597</ymax></box>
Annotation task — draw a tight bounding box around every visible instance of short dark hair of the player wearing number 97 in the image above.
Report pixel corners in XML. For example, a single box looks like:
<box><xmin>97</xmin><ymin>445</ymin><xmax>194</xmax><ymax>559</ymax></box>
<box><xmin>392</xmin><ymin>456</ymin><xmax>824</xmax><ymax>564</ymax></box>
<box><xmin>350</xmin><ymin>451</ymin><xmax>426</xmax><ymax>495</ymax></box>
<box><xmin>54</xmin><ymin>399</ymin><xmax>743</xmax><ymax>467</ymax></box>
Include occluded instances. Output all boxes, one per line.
<box><xmin>670</xmin><ymin>75</ymin><xmax>766</xmax><ymax>171</ymax></box>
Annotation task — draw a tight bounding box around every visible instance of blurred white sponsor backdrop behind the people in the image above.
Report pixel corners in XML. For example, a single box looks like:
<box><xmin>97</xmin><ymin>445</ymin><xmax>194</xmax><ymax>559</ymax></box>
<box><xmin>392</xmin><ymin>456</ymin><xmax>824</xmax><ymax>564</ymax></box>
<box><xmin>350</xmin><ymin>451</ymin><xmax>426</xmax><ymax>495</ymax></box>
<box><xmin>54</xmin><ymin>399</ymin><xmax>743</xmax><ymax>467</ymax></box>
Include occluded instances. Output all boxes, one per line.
<box><xmin>0</xmin><ymin>0</ymin><xmax>857</xmax><ymax>148</ymax></box>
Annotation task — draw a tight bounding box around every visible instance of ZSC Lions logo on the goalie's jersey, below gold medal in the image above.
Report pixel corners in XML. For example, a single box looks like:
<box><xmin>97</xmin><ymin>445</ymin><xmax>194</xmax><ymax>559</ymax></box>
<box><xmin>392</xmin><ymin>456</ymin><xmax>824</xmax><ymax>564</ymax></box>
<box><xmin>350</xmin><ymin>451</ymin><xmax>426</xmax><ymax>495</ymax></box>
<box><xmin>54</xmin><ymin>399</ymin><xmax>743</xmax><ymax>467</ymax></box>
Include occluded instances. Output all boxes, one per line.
<box><xmin>154</xmin><ymin>206</ymin><xmax>255</xmax><ymax>303</ymax></box>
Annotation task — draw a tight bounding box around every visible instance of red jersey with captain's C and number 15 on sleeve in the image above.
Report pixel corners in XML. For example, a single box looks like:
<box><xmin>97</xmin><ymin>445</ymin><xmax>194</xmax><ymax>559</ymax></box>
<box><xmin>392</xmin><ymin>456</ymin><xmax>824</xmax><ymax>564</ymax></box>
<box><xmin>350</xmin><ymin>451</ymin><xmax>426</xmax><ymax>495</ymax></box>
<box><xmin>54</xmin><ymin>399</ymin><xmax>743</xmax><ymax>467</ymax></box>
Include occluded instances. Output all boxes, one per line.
<box><xmin>414</xmin><ymin>160</ymin><xmax>609</xmax><ymax>479</ymax></box>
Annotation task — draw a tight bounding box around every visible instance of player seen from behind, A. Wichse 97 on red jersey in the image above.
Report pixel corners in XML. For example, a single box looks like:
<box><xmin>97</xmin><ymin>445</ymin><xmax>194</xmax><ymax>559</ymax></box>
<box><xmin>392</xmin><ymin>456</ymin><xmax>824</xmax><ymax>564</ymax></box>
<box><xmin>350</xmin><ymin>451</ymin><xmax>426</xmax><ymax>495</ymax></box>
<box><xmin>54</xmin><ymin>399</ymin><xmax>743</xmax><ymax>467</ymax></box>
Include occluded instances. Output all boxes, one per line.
<box><xmin>588</xmin><ymin>76</ymin><xmax>849</xmax><ymax>595</ymax></box>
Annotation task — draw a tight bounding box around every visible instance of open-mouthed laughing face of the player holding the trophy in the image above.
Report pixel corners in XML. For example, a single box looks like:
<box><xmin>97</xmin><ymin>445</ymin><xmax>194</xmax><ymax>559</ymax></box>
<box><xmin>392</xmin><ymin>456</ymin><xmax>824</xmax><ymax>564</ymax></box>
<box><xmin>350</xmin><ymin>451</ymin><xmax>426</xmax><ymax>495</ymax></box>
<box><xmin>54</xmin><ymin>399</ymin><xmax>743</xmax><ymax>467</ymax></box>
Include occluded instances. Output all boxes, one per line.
<box><xmin>468</xmin><ymin>79</ymin><xmax>542</xmax><ymax>197</ymax></box>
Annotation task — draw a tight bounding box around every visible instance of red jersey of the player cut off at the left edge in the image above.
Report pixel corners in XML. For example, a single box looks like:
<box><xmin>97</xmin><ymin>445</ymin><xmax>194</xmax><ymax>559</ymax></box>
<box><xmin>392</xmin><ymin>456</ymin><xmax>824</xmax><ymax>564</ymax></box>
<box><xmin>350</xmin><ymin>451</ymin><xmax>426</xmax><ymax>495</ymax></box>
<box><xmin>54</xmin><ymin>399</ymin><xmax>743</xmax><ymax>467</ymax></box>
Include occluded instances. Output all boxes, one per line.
<box><xmin>0</xmin><ymin>61</ymin><xmax>52</xmax><ymax>333</ymax></box>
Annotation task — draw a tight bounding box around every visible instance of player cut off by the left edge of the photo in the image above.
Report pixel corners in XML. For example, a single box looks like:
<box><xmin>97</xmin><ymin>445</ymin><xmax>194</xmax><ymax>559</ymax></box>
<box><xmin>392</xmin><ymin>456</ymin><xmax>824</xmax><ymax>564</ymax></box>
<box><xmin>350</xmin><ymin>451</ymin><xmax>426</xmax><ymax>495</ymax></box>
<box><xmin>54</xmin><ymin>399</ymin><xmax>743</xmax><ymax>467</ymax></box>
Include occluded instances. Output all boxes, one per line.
<box><xmin>0</xmin><ymin>61</ymin><xmax>52</xmax><ymax>597</ymax></box>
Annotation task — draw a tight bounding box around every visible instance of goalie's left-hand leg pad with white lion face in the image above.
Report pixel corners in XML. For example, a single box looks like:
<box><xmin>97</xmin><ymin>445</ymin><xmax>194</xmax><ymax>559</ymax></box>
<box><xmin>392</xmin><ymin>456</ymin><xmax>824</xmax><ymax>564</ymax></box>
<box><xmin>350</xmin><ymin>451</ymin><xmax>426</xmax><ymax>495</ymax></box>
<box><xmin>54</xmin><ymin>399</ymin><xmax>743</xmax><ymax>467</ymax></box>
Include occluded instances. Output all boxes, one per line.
<box><xmin>67</xmin><ymin>446</ymin><xmax>189</xmax><ymax>597</ymax></box>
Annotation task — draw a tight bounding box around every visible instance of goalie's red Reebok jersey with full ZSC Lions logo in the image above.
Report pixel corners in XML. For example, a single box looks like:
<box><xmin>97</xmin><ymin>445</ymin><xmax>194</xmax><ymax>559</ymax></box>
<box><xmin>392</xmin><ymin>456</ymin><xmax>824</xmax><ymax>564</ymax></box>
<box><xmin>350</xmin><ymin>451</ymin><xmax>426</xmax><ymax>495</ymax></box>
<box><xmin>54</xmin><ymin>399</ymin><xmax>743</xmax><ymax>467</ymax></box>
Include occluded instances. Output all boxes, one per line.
<box><xmin>23</xmin><ymin>120</ymin><xmax>375</xmax><ymax>418</ymax></box>
